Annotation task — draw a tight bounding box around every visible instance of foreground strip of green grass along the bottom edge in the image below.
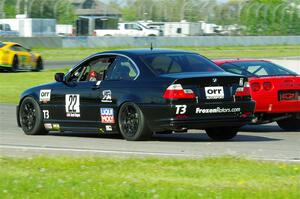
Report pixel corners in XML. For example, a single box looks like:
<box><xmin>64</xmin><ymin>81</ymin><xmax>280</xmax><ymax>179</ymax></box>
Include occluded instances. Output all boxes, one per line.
<box><xmin>0</xmin><ymin>157</ymin><xmax>300</xmax><ymax>199</ymax></box>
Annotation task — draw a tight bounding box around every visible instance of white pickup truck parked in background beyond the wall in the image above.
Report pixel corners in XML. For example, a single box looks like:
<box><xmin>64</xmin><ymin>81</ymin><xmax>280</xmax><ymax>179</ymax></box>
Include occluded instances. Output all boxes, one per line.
<box><xmin>94</xmin><ymin>23</ymin><xmax>160</xmax><ymax>37</ymax></box>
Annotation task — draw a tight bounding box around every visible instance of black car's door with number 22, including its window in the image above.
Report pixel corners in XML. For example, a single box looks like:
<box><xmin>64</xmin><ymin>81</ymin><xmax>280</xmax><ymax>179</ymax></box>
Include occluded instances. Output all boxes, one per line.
<box><xmin>51</xmin><ymin>55</ymin><xmax>116</xmax><ymax>131</ymax></box>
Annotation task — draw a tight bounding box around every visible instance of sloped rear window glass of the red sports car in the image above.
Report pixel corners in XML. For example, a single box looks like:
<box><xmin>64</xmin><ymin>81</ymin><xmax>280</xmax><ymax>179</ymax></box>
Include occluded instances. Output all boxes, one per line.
<box><xmin>221</xmin><ymin>61</ymin><xmax>297</xmax><ymax>77</ymax></box>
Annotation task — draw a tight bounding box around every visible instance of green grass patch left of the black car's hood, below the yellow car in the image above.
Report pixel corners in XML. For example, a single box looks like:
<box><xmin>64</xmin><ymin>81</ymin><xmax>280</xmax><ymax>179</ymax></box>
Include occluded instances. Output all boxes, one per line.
<box><xmin>0</xmin><ymin>69</ymin><xmax>67</xmax><ymax>104</ymax></box>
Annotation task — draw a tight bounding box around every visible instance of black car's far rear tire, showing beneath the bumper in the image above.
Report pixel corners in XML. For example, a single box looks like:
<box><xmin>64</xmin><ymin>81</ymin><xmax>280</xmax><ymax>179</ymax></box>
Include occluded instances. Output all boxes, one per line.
<box><xmin>205</xmin><ymin>127</ymin><xmax>240</xmax><ymax>141</ymax></box>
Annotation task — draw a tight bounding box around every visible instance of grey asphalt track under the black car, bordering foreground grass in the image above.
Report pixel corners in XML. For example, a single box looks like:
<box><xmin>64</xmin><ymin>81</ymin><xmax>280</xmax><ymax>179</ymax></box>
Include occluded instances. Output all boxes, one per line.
<box><xmin>0</xmin><ymin>105</ymin><xmax>300</xmax><ymax>162</ymax></box>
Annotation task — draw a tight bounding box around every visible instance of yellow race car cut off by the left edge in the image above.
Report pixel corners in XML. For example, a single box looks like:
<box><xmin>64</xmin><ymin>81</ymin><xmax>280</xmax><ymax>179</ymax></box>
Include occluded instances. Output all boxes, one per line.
<box><xmin>0</xmin><ymin>42</ymin><xmax>44</xmax><ymax>71</ymax></box>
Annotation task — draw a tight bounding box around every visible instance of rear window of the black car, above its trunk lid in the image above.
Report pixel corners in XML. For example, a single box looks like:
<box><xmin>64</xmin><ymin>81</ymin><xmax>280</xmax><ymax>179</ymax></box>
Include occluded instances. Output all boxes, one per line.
<box><xmin>141</xmin><ymin>53</ymin><xmax>223</xmax><ymax>75</ymax></box>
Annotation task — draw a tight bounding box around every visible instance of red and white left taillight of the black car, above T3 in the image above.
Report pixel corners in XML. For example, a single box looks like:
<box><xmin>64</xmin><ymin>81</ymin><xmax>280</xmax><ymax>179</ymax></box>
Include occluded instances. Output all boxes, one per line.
<box><xmin>164</xmin><ymin>84</ymin><xmax>196</xmax><ymax>99</ymax></box>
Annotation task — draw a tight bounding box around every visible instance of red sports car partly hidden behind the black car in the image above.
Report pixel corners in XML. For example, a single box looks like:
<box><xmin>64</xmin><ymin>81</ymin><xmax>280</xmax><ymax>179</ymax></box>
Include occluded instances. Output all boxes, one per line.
<box><xmin>213</xmin><ymin>59</ymin><xmax>300</xmax><ymax>131</ymax></box>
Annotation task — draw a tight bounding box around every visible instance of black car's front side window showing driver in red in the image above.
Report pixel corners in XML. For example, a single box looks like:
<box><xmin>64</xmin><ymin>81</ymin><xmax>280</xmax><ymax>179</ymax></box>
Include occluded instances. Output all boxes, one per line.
<box><xmin>68</xmin><ymin>56</ymin><xmax>116</xmax><ymax>82</ymax></box>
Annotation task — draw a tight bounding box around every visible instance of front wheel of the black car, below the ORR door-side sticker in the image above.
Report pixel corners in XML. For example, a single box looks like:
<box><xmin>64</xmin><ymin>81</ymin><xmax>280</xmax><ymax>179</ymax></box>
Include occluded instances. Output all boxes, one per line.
<box><xmin>19</xmin><ymin>97</ymin><xmax>48</xmax><ymax>135</ymax></box>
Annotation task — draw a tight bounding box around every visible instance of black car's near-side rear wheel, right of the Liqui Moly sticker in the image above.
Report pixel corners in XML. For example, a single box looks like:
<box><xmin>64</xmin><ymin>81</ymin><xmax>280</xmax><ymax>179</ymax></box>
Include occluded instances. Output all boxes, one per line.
<box><xmin>118</xmin><ymin>102</ymin><xmax>153</xmax><ymax>141</ymax></box>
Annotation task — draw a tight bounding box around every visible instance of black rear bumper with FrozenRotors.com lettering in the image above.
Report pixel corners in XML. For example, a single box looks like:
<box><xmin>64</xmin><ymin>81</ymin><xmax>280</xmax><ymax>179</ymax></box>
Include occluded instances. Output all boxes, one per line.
<box><xmin>140</xmin><ymin>101</ymin><xmax>255</xmax><ymax>132</ymax></box>
